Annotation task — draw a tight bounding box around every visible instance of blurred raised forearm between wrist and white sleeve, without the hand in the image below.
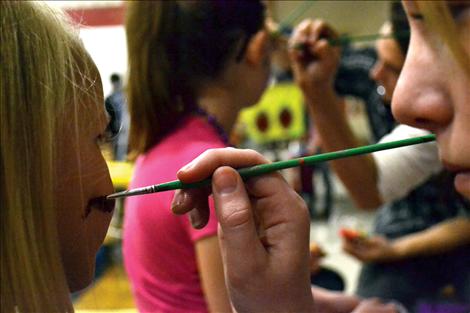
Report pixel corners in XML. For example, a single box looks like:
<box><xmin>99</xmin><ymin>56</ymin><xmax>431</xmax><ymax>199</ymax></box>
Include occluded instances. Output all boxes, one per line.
<box><xmin>304</xmin><ymin>88</ymin><xmax>382</xmax><ymax>209</ymax></box>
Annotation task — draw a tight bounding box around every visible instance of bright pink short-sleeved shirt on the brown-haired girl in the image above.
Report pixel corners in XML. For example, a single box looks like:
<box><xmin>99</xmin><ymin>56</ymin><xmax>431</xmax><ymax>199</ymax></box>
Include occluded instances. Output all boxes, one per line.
<box><xmin>123</xmin><ymin>117</ymin><xmax>224</xmax><ymax>313</ymax></box>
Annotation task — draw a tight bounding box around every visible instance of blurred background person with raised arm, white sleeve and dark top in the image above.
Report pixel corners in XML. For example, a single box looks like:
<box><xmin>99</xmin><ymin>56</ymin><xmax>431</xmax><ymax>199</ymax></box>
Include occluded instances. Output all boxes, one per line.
<box><xmin>292</xmin><ymin>2</ymin><xmax>470</xmax><ymax>310</ymax></box>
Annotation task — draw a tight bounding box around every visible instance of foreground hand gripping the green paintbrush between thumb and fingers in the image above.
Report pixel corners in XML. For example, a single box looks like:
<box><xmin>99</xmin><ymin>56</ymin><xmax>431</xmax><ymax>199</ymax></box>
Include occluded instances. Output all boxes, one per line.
<box><xmin>172</xmin><ymin>148</ymin><xmax>313</xmax><ymax>312</ymax></box>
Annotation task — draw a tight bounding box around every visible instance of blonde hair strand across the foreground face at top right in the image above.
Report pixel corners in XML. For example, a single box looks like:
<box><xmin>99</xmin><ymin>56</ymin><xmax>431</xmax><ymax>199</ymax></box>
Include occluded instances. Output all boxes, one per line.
<box><xmin>417</xmin><ymin>0</ymin><xmax>470</xmax><ymax>75</ymax></box>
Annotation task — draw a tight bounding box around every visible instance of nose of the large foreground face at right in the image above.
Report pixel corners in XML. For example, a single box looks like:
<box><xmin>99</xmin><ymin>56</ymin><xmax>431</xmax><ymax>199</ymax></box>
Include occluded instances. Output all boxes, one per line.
<box><xmin>392</xmin><ymin>49</ymin><xmax>453</xmax><ymax>132</ymax></box>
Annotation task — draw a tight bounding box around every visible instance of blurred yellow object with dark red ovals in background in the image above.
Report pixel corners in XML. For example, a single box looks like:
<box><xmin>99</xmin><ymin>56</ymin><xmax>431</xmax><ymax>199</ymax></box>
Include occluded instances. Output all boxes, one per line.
<box><xmin>239</xmin><ymin>83</ymin><xmax>305</xmax><ymax>144</ymax></box>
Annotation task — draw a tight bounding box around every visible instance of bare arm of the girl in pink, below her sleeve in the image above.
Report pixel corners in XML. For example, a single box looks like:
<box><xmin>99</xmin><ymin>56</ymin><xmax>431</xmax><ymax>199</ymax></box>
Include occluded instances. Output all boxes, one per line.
<box><xmin>196</xmin><ymin>236</ymin><xmax>232</xmax><ymax>312</ymax></box>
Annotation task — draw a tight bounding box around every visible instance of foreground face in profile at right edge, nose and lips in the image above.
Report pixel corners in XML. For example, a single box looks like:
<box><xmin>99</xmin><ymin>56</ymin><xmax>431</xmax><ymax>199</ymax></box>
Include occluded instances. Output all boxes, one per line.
<box><xmin>392</xmin><ymin>1</ymin><xmax>470</xmax><ymax>198</ymax></box>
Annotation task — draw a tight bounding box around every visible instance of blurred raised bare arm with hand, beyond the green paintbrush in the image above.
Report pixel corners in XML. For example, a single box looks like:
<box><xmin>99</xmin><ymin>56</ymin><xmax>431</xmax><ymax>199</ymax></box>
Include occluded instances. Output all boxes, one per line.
<box><xmin>291</xmin><ymin>21</ymin><xmax>382</xmax><ymax>209</ymax></box>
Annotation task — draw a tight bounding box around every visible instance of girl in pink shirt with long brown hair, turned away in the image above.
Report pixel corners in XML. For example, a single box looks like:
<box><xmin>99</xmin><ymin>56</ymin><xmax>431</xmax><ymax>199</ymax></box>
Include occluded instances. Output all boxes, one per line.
<box><xmin>123</xmin><ymin>1</ymin><xmax>270</xmax><ymax>312</ymax></box>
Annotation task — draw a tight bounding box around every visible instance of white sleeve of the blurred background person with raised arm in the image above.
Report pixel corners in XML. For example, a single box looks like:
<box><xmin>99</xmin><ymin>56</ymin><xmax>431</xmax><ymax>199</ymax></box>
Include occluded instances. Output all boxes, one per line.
<box><xmin>372</xmin><ymin>125</ymin><xmax>442</xmax><ymax>203</ymax></box>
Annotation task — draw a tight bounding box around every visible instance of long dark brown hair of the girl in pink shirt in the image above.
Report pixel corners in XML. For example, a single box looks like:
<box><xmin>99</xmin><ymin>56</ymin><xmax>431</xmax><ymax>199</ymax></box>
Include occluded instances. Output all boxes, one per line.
<box><xmin>126</xmin><ymin>0</ymin><xmax>264</xmax><ymax>154</ymax></box>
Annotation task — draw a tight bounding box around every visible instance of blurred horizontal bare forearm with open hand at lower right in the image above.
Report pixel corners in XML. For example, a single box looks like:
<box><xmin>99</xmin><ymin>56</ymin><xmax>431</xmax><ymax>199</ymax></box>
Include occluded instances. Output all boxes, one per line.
<box><xmin>343</xmin><ymin>217</ymin><xmax>470</xmax><ymax>262</ymax></box>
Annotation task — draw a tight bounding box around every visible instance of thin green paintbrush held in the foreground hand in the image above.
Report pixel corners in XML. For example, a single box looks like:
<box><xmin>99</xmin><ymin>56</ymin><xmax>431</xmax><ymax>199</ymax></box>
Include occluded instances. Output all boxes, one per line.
<box><xmin>107</xmin><ymin>135</ymin><xmax>436</xmax><ymax>199</ymax></box>
